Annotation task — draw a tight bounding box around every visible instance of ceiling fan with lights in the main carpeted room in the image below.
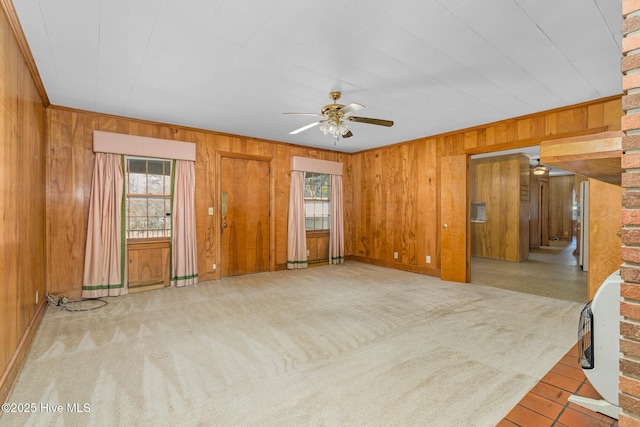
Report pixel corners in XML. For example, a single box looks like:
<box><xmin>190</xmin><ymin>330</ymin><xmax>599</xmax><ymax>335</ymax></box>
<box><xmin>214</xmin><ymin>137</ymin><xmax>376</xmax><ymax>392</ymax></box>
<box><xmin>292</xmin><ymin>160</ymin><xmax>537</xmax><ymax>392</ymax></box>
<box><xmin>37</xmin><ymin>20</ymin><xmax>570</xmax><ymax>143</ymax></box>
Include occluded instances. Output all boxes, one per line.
<box><xmin>284</xmin><ymin>91</ymin><xmax>393</xmax><ymax>141</ymax></box>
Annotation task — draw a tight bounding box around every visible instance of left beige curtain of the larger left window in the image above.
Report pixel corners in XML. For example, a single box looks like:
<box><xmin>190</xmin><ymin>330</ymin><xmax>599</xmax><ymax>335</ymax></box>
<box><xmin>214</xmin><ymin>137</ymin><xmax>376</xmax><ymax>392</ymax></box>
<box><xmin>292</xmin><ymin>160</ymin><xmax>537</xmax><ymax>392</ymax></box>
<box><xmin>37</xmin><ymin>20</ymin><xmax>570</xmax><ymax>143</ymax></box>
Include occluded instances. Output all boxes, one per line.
<box><xmin>82</xmin><ymin>153</ymin><xmax>127</xmax><ymax>298</ymax></box>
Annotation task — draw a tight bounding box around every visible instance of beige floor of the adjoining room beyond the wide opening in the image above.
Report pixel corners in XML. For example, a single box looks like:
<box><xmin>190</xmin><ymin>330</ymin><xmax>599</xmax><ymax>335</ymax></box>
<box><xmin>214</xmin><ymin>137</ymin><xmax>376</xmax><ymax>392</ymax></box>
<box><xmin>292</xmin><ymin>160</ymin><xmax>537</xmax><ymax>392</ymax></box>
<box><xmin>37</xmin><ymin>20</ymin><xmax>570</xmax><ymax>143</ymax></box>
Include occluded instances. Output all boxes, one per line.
<box><xmin>471</xmin><ymin>240</ymin><xmax>588</xmax><ymax>304</ymax></box>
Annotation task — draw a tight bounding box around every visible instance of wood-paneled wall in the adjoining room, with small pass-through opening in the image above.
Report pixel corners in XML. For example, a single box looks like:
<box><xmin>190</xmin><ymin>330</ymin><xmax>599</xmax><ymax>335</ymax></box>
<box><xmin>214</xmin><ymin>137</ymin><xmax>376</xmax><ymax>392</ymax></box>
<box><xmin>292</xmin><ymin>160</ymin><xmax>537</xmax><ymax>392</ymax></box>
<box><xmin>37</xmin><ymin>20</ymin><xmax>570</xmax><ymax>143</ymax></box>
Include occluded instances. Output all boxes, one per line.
<box><xmin>471</xmin><ymin>154</ymin><xmax>529</xmax><ymax>262</ymax></box>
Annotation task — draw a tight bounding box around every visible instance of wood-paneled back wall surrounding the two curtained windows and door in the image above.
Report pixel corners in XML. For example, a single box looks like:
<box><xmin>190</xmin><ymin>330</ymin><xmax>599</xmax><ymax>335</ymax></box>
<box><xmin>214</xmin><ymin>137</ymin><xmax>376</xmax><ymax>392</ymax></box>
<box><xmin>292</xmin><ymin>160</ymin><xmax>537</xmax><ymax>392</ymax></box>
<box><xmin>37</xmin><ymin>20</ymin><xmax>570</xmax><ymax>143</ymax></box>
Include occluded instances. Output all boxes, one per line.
<box><xmin>47</xmin><ymin>107</ymin><xmax>352</xmax><ymax>296</ymax></box>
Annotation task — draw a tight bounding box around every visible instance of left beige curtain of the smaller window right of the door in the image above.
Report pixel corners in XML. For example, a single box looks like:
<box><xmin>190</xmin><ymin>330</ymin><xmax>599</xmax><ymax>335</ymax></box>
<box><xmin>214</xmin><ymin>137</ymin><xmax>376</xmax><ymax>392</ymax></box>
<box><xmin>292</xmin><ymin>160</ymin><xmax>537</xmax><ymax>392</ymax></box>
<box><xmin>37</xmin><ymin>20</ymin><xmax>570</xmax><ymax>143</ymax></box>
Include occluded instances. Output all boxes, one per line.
<box><xmin>287</xmin><ymin>171</ymin><xmax>308</xmax><ymax>270</ymax></box>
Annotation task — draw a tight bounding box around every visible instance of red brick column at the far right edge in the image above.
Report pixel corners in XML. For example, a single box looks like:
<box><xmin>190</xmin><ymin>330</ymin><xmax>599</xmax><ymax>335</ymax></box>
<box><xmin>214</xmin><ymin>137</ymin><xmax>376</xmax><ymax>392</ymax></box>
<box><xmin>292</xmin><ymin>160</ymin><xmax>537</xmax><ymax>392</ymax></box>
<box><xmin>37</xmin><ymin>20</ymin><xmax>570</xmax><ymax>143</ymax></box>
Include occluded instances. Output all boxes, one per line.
<box><xmin>619</xmin><ymin>0</ymin><xmax>640</xmax><ymax>427</ymax></box>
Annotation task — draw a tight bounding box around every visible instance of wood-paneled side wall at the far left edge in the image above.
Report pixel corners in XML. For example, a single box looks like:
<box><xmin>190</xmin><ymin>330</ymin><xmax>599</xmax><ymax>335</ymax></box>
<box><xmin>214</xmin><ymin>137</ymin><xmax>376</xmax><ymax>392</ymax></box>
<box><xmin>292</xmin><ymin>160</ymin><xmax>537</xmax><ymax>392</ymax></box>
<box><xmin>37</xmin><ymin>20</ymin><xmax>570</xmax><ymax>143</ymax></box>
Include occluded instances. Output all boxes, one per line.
<box><xmin>0</xmin><ymin>5</ymin><xmax>46</xmax><ymax>402</ymax></box>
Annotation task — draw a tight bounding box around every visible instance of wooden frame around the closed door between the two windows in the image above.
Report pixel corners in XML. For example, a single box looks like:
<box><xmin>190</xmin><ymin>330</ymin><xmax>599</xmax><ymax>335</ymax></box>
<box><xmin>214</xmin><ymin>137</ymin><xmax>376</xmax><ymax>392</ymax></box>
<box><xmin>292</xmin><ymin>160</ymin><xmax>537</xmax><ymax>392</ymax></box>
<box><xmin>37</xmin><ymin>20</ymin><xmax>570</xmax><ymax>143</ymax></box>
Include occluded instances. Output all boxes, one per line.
<box><xmin>213</xmin><ymin>151</ymin><xmax>276</xmax><ymax>280</ymax></box>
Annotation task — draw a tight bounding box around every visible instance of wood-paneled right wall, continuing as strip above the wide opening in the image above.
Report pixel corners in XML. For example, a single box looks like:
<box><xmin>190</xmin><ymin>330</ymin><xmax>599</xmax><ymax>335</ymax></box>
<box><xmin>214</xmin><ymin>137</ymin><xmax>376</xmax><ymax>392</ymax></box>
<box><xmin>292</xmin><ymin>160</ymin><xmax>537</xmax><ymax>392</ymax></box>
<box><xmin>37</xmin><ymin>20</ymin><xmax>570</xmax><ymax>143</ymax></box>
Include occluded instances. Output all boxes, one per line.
<box><xmin>345</xmin><ymin>96</ymin><xmax>622</xmax><ymax>275</ymax></box>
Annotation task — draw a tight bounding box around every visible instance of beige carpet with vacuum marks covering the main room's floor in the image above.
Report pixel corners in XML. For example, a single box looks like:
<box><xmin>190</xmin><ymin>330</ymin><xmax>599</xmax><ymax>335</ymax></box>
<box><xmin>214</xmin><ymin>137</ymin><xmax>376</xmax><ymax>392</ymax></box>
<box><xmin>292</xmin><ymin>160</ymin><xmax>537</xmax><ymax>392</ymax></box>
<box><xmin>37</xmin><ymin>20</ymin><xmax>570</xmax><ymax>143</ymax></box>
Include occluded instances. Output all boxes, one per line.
<box><xmin>0</xmin><ymin>262</ymin><xmax>582</xmax><ymax>426</ymax></box>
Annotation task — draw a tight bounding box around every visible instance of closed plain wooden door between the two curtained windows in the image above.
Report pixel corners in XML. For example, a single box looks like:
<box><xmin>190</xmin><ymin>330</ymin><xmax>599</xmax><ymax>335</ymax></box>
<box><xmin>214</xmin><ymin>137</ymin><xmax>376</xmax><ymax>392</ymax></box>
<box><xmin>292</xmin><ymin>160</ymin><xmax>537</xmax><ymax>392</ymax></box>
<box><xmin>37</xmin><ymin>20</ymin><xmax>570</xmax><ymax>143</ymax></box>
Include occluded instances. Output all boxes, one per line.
<box><xmin>220</xmin><ymin>157</ymin><xmax>270</xmax><ymax>277</ymax></box>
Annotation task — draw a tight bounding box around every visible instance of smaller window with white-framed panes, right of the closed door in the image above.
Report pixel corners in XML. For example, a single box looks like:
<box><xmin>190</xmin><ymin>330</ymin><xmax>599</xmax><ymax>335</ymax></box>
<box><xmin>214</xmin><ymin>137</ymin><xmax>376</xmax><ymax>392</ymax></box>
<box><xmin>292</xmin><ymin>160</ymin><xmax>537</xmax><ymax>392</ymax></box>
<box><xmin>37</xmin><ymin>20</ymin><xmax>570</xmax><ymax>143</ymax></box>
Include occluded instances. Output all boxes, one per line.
<box><xmin>304</xmin><ymin>172</ymin><xmax>331</xmax><ymax>230</ymax></box>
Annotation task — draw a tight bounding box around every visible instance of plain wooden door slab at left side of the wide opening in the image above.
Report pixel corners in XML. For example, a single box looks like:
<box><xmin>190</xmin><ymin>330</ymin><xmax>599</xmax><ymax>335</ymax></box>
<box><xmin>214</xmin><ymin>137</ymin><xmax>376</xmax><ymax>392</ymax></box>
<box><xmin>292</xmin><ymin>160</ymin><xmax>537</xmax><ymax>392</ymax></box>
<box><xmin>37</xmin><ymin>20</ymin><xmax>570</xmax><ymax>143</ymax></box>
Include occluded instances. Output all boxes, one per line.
<box><xmin>440</xmin><ymin>154</ymin><xmax>471</xmax><ymax>283</ymax></box>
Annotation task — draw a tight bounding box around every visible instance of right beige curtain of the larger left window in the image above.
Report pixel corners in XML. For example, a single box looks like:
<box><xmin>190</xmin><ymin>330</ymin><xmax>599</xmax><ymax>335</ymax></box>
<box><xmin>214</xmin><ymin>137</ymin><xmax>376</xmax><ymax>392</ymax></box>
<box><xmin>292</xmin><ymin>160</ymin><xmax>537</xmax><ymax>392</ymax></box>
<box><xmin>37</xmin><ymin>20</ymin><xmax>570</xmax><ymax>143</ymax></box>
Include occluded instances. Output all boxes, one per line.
<box><xmin>171</xmin><ymin>160</ymin><xmax>198</xmax><ymax>286</ymax></box>
